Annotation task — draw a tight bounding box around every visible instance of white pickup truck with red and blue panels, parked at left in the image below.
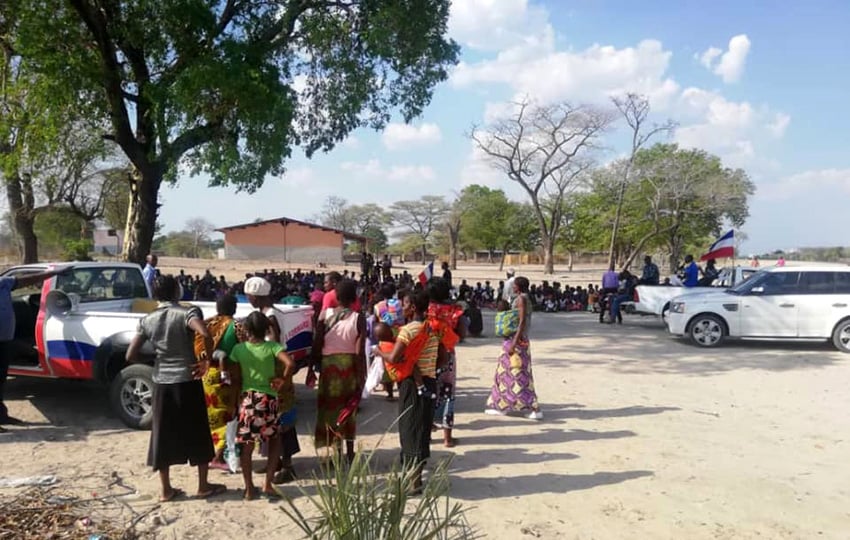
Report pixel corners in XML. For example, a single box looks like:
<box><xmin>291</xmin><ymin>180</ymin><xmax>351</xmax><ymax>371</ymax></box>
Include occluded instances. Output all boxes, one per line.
<box><xmin>0</xmin><ymin>262</ymin><xmax>313</xmax><ymax>429</ymax></box>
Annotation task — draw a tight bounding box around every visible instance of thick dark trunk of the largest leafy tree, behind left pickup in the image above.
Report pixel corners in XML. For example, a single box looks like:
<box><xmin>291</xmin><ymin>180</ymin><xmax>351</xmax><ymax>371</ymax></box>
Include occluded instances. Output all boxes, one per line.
<box><xmin>123</xmin><ymin>169</ymin><xmax>162</xmax><ymax>264</ymax></box>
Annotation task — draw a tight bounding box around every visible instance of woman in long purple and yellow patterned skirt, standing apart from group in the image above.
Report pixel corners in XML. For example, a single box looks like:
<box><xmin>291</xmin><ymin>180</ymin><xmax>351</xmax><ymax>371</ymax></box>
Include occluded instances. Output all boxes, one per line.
<box><xmin>484</xmin><ymin>276</ymin><xmax>543</xmax><ymax>420</ymax></box>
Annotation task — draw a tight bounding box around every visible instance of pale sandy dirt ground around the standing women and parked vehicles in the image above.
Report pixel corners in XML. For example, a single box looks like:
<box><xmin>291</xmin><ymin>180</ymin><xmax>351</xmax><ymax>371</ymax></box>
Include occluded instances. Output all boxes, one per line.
<box><xmin>0</xmin><ymin>288</ymin><xmax>850</xmax><ymax>539</ymax></box>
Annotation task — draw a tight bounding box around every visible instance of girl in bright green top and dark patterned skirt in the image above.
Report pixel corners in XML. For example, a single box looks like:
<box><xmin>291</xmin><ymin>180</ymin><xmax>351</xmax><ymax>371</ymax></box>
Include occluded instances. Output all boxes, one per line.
<box><xmin>230</xmin><ymin>311</ymin><xmax>295</xmax><ymax>500</ymax></box>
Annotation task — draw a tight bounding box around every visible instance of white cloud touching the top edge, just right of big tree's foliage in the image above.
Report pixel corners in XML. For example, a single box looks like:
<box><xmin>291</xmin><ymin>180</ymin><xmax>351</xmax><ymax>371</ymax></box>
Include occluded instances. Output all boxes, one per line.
<box><xmin>449</xmin><ymin>0</ymin><xmax>550</xmax><ymax>51</ymax></box>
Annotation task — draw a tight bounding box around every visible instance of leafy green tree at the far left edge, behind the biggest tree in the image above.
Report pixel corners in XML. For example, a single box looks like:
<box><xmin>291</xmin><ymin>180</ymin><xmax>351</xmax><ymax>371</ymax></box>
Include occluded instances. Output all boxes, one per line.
<box><xmin>0</xmin><ymin>21</ymin><xmax>126</xmax><ymax>263</ymax></box>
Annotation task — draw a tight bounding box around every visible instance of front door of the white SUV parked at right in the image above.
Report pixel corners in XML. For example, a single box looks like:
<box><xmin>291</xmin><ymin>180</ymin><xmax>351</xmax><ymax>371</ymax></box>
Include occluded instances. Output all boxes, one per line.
<box><xmin>741</xmin><ymin>272</ymin><xmax>800</xmax><ymax>338</ymax></box>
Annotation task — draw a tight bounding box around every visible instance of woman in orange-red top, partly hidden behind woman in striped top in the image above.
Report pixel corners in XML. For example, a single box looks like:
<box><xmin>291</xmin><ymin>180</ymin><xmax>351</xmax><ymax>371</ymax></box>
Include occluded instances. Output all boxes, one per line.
<box><xmin>428</xmin><ymin>278</ymin><xmax>466</xmax><ymax>448</ymax></box>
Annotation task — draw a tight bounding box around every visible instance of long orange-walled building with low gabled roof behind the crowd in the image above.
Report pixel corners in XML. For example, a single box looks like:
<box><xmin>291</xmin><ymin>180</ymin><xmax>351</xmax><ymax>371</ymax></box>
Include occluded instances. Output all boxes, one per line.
<box><xmin>217</xmin><ymin>217</ymin><xmax>367</xmax><ymax>264</ymax></box>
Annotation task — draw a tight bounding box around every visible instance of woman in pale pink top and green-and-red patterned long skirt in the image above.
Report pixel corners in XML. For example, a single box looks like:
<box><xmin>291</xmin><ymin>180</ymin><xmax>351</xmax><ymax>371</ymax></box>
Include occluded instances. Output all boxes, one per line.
<box><xmin>313</xmin><ymin>279</ymin><xmax>366</xmax><ymax>462</ymax></box>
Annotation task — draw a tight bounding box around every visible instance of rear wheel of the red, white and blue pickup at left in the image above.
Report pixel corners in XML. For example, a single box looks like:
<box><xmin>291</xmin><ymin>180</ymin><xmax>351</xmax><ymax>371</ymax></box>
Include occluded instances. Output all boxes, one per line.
<box><xmin>109</xmin><ymin>364</ymin><xmax>153</xmax><ymax>429</ymax></box>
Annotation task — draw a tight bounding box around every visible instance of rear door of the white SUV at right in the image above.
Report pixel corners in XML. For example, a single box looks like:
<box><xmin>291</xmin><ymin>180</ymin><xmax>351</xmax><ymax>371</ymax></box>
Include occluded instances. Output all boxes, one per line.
<box><xmin>797</xmin><ymin>271</ymin><xmax>836</xmax><ymax>338</ymax></box>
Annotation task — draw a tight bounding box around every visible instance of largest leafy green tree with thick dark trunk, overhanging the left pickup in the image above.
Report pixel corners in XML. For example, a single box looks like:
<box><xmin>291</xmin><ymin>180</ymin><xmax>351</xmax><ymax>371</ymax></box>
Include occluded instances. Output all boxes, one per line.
<box><xmin>4</xmin><ymin>0</ymin><xmax>458</xmax><ymax>262</ymax></box>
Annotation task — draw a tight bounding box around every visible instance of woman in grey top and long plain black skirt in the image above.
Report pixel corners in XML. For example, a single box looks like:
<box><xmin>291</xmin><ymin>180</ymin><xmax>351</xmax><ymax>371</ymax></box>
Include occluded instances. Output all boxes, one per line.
<box><xmin>127</xmin><ymin>275</ymin><xmax>227</xmax><ymax>502</ymax></box>
